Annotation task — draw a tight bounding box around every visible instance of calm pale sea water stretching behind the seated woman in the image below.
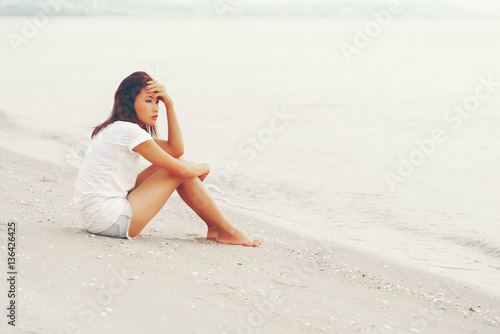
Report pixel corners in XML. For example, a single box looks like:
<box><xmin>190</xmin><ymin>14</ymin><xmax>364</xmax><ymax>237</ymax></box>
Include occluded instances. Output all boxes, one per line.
<box><xmin>0</xmin><ymin>17</ymin><xmax>500</xmax><ymax>293</ymax></box>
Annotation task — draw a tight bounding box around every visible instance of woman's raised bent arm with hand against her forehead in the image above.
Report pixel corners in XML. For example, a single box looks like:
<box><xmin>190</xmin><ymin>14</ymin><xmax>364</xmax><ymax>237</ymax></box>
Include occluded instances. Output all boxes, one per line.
<box><xmin>146</xmin><ymin>81</ymin><xmax>184</xmax><ymax>158</ymax></box>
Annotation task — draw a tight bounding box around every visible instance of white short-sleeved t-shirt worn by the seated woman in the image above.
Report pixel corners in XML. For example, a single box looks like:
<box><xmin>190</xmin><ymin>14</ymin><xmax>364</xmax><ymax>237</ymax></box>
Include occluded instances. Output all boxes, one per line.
<box><xmin>73</xmin><ymin>121</ymin><xmax>153</xmax><ymax>233</ymax></box>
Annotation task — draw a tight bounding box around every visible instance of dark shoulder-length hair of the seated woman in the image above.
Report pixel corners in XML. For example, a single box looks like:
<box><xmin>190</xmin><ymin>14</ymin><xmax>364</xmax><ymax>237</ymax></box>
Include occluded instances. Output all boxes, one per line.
<box><xmin>91</xmin><ymin>72</ymin><xmax>157</xmax><ymax>138</ymax></box>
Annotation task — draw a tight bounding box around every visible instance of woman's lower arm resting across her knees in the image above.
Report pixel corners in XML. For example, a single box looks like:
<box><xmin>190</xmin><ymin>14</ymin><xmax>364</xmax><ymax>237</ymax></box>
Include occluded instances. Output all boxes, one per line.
<box><xmin>134</xmin><ymin>140</ymin><xmax>210</xmax><ymax>178</ymax></box>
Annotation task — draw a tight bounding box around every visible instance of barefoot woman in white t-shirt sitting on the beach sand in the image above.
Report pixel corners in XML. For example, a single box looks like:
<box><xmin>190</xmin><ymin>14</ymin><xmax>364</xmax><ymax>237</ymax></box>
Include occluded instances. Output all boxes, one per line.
<box><xmin>74</xmin><ymin>72</ymin><xmax>261</xmax><ymax>247</ymax></box>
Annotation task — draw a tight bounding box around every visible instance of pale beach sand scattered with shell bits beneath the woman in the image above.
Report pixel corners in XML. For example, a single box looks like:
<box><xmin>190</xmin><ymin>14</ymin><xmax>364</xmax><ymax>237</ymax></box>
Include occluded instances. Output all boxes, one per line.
<box><xmin>0</xmin><ymin>149</ymin><xmax>500</xmax><ymax>334</ymax></box>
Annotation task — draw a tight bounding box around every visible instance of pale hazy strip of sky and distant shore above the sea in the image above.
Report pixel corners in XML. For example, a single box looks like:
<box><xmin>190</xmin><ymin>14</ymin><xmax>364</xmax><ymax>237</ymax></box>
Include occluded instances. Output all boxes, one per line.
<box><xmin>0</xmin><ymin>0</ymin><xmax>500</xmax><ymax>18</ymax></box>
